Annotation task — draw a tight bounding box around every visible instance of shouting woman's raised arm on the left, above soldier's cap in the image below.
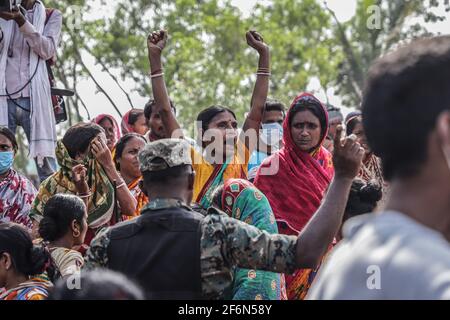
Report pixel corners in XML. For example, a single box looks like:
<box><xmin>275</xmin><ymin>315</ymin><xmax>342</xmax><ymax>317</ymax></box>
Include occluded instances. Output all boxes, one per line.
<box><xmin>147</xmin><ymin>30</ymin><xmax>183</xmax><ymax>138</ymax></box>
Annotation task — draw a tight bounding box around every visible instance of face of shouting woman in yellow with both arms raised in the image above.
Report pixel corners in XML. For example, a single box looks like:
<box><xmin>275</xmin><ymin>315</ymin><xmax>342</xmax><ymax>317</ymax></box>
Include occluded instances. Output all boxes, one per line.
<box><xmin>203</xmin><ymin>111</ymin><xmax>238</xmax><ymax>155</ymax></box>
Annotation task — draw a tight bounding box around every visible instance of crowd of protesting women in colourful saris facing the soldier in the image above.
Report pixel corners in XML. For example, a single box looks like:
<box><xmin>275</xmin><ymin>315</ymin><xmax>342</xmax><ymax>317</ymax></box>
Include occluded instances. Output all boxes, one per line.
<box><xmin>0</xmin><ymin>31</ymin><xmax>388</xmax><ymax>300</ymax></box>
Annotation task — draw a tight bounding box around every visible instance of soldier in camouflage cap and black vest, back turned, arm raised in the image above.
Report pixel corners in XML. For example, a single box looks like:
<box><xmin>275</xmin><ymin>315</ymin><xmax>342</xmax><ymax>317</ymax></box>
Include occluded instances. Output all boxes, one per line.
<box><xmin>86</xmin><ymin>131</ymin><xmax>364</xmax><ymax>299</ymax></box>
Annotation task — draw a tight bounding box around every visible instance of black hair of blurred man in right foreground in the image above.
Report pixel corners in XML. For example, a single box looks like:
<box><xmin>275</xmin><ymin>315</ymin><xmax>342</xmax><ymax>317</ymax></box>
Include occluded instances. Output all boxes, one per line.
<box><xmin>362</xmin><ymin>36</ymin><xmax>450</xmax><ymax>181</ymax></box>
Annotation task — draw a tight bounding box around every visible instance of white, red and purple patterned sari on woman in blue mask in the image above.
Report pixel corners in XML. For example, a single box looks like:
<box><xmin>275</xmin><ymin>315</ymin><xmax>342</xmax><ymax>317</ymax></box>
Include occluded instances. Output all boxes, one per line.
<box><xmin>0</xmin><ymin>169</ymin><xmax>37</xmax><ymax>230</ymax></box>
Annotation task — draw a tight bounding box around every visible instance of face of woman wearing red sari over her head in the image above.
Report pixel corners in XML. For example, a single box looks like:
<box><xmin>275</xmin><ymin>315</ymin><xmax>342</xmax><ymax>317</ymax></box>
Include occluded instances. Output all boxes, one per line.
<box><xmin>291</xmin><ymin>110</ymin><xmax>322</xmax><ymax>152</ymax></box>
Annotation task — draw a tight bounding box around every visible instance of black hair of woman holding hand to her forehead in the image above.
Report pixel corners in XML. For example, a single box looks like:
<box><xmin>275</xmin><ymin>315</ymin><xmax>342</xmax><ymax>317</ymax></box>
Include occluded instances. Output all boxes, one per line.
<box><xmin>62</xmin><ymin>122</ymin><xmax>105</xmax><ymax>159</ymax></box>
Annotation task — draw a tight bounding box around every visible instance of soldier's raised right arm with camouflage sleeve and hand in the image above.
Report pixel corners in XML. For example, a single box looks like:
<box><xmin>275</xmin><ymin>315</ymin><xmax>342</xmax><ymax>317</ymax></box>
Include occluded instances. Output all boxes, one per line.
<box><xmin>221</xmin><ymin>127</ymin><xmax>364</xmax><ymax>273</ymax></box>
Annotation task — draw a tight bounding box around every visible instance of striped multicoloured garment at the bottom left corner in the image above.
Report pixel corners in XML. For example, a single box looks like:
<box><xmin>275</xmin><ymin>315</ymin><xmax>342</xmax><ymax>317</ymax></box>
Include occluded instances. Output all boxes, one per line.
<box><xmin>0</xmin><ymin>278</ymin><xmax>53</xmax><ymax>300</ymax></box>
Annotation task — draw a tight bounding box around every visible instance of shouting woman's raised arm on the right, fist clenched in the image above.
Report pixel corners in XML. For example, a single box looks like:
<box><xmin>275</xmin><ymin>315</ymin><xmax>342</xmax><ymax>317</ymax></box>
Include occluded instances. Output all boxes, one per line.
<box><xmin>241</xmin><ymin>31</ymin><xmax>270</xmax><ymax>152</ymax></box>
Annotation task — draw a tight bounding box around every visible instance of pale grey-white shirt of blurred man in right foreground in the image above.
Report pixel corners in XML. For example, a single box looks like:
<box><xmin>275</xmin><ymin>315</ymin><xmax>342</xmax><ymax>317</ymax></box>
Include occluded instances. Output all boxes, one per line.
<box><xmin>307</xmin><ymin>211</ymin><xmax>450</xmax><ymax>300</ymax></box>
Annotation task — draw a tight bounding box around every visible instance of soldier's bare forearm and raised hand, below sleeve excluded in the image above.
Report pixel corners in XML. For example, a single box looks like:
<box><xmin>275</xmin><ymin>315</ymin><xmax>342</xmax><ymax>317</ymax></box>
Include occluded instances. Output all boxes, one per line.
<box><xmin>297</xmin><ymin>126</ymin><xmax>364</xmax><ymax>269</ymax></box>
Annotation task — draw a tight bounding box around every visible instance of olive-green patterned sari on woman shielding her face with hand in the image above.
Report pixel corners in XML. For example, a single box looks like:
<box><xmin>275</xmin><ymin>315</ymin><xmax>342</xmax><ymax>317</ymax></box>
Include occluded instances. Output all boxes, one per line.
<box><xmin>30</xmin><ymin>141</ymin><xmax>115</xmax><ymax>229</ymax></box>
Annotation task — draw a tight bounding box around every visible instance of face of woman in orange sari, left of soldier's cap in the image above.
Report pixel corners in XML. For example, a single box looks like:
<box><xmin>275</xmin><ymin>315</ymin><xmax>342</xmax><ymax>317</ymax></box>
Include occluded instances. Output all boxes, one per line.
<box><xmin>117</xmin><ymin>137</ymin><xmax>145</xmax><ymax>179</ymax></box>
